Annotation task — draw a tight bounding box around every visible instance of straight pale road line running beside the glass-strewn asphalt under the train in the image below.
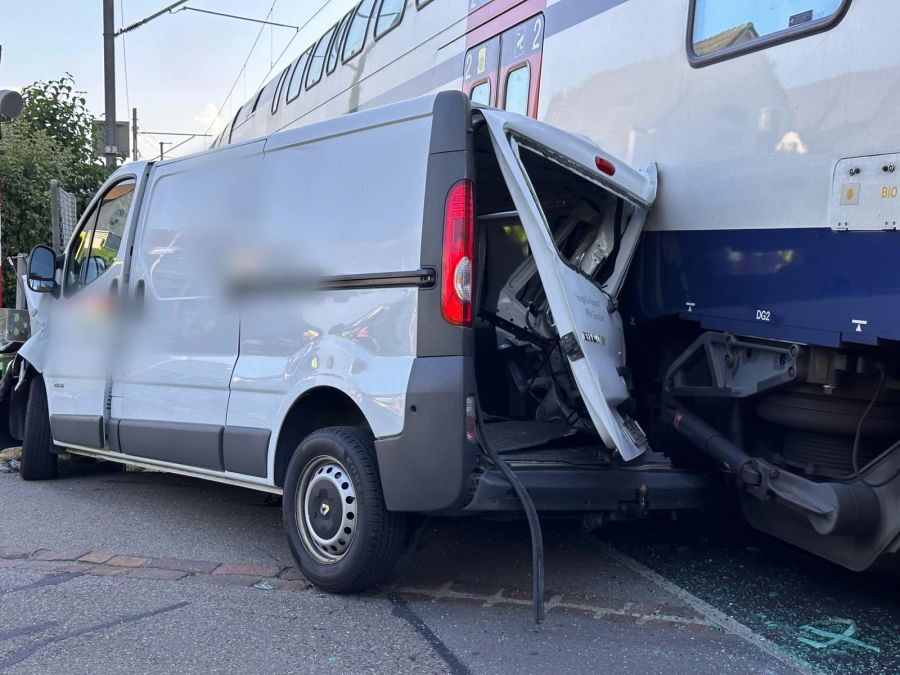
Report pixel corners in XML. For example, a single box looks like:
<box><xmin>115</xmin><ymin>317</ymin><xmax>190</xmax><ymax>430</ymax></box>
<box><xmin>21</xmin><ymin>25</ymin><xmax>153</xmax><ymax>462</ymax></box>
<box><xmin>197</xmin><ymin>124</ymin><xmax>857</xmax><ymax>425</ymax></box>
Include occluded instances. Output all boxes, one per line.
<box><xmin>598</xmin><ymin>542</ymin><xmax>822</xmax><ymax>675</ymax></box>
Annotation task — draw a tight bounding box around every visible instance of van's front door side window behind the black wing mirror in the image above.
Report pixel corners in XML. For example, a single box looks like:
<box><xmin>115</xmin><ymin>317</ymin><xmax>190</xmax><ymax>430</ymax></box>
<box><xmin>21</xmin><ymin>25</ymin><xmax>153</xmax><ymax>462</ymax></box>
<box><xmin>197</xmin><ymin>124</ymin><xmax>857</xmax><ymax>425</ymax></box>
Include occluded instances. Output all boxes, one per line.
<box><xmin>63</xmin><ymin>178</ymin><xmax>135</xmax><ymax>295</ymax></box>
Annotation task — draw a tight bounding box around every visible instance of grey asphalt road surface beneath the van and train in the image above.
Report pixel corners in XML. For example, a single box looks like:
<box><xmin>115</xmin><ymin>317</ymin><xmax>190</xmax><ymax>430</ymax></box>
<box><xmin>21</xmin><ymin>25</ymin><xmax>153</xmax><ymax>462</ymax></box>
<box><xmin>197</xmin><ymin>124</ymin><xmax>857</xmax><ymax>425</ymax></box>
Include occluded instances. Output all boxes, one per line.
<box><xmin>0</xmin><ymin>462</ymin><xmax>900</xmax><ymax>673</ymax></box>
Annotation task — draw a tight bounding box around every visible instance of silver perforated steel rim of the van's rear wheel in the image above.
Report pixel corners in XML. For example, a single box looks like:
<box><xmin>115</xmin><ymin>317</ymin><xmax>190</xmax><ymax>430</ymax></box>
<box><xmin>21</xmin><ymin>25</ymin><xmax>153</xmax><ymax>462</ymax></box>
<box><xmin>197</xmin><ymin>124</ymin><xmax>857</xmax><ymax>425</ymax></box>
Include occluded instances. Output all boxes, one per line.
<box><xmin>295</xmin><ymin>455</ymin><xmax>359</xmax><ymax>564</ymax></box>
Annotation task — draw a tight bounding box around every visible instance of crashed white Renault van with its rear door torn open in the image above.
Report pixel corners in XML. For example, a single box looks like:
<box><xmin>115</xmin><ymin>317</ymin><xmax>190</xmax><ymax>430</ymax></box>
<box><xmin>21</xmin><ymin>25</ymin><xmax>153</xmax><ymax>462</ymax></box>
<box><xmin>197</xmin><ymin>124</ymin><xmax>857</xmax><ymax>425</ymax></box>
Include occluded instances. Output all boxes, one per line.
<box><xmin>3</xmin><ymin>92</ymin><xmax>704</xmax><ymax>592</ymax></box>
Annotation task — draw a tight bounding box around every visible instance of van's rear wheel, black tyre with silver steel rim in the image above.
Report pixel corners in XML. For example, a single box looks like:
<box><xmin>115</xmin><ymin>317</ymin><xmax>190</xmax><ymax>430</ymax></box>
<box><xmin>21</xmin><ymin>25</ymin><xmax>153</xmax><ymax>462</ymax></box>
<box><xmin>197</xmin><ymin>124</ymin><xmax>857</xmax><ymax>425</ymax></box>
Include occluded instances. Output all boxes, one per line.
<box><xmin>282</xmin><ymin>427</ymin><xmax>407</xmax><ymax>593</ymax></box>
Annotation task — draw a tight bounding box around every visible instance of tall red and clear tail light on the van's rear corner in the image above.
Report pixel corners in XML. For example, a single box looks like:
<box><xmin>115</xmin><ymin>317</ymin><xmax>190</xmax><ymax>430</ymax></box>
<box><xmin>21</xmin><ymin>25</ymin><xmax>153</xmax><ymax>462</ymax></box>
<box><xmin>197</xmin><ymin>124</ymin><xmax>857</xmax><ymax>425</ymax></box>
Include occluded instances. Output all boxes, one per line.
<box><xmin>441</xmin><ymin>180</ymin><xmax>475</xmax><ymax>326</ymax></box>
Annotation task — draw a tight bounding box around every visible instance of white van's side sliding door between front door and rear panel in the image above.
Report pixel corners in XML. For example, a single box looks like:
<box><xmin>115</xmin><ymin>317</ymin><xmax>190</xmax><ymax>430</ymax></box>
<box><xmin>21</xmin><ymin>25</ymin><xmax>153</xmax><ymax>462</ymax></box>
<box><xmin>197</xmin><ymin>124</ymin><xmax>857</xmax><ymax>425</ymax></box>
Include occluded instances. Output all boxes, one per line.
<box><xmin>111</xmin><ymin>141</ymin><xmax>263</xmax><ymax>471</ymax></box>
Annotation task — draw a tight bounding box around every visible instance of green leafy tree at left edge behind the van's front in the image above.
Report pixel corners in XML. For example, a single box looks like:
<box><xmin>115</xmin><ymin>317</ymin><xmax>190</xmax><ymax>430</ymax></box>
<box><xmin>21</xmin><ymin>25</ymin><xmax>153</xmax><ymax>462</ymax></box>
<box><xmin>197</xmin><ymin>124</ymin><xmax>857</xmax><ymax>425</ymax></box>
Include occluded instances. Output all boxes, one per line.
<box><xmin>0</xmin><ymin>75</ymin><xmax>109</xmax><ymax>307</ymax></box>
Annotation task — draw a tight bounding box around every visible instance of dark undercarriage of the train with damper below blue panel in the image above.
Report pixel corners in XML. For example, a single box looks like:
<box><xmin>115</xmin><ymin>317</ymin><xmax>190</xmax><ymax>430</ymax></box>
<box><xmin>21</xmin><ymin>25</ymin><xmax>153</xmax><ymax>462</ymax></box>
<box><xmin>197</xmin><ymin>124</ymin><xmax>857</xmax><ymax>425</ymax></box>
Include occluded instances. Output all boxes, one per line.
<box><xmin>642</xmin><ymin>329</ymin><xmax>900</xmax><ymax>571</ymax></box>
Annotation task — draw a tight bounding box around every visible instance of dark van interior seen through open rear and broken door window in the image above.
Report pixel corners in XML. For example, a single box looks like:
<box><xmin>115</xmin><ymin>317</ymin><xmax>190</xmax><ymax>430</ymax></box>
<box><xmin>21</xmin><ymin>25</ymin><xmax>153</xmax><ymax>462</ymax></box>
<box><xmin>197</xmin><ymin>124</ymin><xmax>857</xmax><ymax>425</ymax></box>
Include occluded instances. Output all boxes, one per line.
<box><xmin>473</xmin><ymin>116</ymin><xmax>631</xmax><ymax>463</ymax></box>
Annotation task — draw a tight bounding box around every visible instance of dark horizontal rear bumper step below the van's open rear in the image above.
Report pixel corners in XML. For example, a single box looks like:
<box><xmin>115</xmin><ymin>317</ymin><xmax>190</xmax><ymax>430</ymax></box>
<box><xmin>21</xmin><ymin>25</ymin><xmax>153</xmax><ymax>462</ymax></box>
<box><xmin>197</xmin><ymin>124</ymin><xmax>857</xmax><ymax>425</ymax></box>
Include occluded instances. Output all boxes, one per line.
<box><xmin>463</xmin><ymin>464</ymin><xmax>719</xmax><ymax>516</ymax></box>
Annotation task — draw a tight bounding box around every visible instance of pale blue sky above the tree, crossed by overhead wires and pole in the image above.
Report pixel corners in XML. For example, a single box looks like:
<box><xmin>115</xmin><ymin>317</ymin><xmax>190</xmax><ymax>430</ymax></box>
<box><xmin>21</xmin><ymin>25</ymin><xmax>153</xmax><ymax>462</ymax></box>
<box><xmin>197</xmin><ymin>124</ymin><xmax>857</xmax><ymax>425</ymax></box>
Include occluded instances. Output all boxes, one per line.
<box><xmin>0</xmin><ymin>0</ymin><xmax>356</xmax><ymax>158</ymax></box>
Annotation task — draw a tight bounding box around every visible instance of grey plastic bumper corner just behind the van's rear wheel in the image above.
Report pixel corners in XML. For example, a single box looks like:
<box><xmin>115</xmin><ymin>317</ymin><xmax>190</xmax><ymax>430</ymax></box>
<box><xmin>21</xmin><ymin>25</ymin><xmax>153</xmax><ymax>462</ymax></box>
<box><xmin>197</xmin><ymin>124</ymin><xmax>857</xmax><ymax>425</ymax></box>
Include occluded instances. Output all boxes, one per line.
<box><xmin>375</xmin><ymin>356</ymin><xmax>477</xmax><ymax>513</ymax></box>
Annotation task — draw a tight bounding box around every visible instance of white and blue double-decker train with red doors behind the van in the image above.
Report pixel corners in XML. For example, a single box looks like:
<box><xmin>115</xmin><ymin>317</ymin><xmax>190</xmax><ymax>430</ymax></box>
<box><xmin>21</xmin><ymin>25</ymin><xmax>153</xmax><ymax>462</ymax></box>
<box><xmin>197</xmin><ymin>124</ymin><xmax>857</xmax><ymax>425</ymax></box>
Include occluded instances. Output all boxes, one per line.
<box><xmin>214</xmin><ymin>0</ymin><xmax>900</xmax><ymax>570</ymax></box>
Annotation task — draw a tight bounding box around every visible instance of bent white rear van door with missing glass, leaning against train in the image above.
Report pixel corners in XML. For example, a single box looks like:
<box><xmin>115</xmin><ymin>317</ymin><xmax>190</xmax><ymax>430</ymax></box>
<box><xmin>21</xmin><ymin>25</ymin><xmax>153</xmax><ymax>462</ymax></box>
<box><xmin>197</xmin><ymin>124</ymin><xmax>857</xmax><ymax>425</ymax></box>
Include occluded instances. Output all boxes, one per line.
<box><xmin>479</xmin><ymin>109</ymin><xmax>656</xmax><ymax>461</ymax></box>
